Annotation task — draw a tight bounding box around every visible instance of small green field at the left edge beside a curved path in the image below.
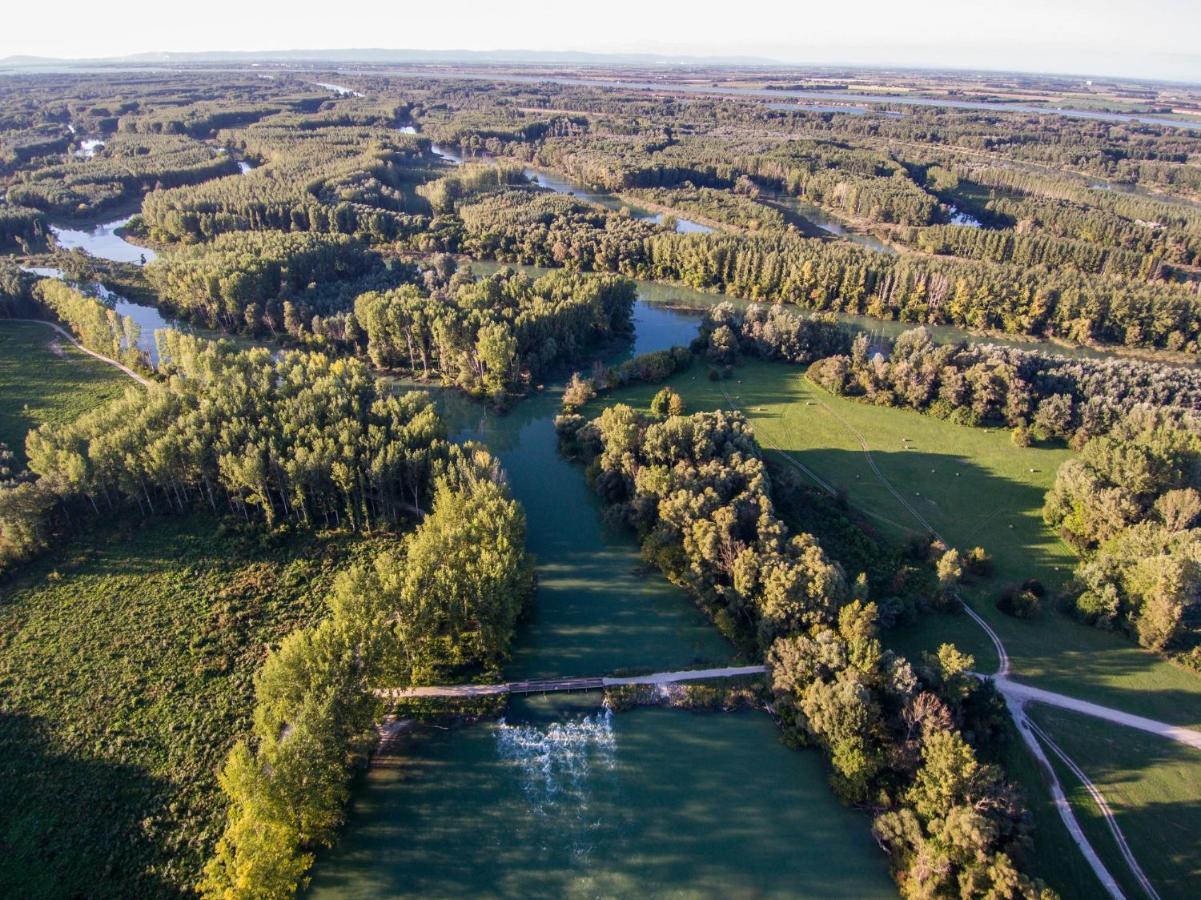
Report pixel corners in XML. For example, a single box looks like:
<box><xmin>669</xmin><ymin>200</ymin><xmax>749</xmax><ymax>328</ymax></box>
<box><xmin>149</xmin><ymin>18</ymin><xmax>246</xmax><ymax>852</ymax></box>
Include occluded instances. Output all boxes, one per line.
<box><xmin>0</xmin><ymin>318</ymin><xmax>132</xmax><ymax>465</ymax></box>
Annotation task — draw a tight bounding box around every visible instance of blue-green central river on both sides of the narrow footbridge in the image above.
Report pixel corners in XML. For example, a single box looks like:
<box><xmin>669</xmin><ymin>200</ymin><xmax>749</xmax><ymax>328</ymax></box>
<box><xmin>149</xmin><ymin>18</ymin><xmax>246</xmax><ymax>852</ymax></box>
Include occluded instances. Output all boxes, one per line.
<box><xmin>309</xmin><ymin>293</ymin><xmax>895</xmax><ymax>898</ymax></box>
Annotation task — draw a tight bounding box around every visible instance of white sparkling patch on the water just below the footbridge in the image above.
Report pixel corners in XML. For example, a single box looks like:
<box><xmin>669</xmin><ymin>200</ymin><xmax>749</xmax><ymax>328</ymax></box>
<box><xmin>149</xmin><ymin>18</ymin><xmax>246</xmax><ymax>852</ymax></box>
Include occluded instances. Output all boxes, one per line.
<box><xmin>496</xmin><ymin>709</ymin><xmax>617</xmax><ymax>858</ymax></box>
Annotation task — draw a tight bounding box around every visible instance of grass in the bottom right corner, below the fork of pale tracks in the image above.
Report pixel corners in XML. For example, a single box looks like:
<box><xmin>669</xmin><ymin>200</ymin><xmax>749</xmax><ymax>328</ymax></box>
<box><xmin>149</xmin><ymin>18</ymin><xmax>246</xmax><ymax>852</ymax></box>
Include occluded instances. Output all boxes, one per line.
<box><xmin>1030</xmin><ymin>705</ymin><xmax>1201</xmax><ymax>898</ymax></box>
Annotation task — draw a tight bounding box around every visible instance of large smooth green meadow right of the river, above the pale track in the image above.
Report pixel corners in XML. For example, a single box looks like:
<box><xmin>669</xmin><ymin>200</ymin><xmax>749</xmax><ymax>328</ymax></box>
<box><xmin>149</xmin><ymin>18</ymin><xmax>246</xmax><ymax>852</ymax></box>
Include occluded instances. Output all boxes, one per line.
<box><xmin>600</xmin><ymin>362</ymin><xmax>1201</xmax><ymax>727</ymax></box>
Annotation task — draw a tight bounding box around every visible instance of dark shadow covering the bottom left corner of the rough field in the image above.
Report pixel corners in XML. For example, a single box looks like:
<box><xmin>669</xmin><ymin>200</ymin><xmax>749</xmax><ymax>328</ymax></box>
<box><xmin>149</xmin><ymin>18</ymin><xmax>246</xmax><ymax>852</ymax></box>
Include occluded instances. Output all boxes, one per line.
<box><xmin>0</xmin><ymin>714</ymin><xmax>168</xmax><ymax>898</ymax></box>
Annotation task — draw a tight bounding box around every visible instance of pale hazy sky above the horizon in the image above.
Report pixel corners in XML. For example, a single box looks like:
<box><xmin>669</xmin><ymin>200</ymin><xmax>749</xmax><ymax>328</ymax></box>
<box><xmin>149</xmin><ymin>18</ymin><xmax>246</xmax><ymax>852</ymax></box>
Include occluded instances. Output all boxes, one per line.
<box><xmin>9</xmin><ymin>0</ymin><xmax>1201</xmax><ymax>82</ymax></box>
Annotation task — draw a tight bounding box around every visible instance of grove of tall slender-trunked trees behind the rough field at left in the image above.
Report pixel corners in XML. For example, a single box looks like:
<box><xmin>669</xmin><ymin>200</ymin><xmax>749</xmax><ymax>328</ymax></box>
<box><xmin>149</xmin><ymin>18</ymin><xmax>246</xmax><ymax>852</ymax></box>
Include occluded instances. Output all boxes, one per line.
<box><xmin>0</xmin><ymin>330</ymin><xmax>446</xmax><ymax>567</ymax></box>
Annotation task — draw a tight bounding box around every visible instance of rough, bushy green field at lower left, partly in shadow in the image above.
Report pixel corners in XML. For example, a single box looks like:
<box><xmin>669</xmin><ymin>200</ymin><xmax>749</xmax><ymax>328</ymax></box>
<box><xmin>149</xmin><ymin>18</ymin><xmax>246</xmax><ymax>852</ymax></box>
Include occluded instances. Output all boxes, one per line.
<box><xmin>0</xmin><ymin>517</ymin><xmax>382</xmax><ymax>898</ymax></box>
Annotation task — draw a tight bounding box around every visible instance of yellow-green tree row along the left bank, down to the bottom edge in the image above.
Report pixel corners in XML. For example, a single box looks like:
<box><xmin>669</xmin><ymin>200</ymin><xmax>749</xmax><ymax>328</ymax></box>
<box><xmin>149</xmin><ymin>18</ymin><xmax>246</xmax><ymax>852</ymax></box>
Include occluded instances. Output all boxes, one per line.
<box><xmin>199</xmin><ymin>445</ymin><xmax>533</xmax><ymax>898</ymax></box>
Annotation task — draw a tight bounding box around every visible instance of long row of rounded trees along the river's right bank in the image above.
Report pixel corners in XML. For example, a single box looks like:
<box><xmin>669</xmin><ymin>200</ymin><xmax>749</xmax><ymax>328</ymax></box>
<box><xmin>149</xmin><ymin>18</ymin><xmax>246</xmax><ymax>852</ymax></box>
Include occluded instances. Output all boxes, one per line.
<box><xmin>557</xmin><ymin>405</ymin><xmax>1045</xmax><ymax>898</ymax></box>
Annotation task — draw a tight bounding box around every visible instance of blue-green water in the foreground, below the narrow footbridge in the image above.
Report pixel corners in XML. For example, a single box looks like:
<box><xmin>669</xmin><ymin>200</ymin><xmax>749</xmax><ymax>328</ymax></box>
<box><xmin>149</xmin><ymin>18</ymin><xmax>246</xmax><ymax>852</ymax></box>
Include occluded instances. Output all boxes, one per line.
<box><xmin>309</xmin><ymin>696</ymin><xmax>896</xmax><ymax>898</ymax></box>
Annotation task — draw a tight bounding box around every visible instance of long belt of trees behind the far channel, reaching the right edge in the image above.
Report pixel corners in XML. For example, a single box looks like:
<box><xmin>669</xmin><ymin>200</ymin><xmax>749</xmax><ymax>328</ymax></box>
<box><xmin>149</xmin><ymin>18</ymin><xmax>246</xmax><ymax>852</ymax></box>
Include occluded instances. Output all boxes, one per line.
<box><xmin>434</xmin><ymin>191</ymin><xmax>1201</xmax><ymax>352</ymax></box>
